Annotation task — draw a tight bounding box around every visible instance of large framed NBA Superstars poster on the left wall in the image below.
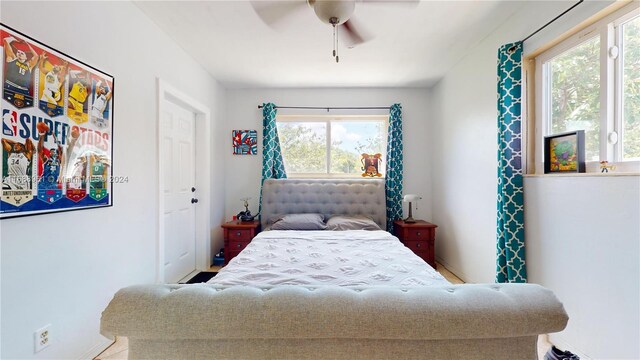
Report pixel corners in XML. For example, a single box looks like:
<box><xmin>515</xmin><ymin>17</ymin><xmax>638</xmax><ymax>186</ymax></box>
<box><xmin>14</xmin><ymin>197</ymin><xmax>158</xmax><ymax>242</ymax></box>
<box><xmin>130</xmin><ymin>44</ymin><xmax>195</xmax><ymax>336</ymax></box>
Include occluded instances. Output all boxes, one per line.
<box><xmin>0</xmin><ymin>24</ymin><xmax>114</xmax><ymax>219</ymax></box>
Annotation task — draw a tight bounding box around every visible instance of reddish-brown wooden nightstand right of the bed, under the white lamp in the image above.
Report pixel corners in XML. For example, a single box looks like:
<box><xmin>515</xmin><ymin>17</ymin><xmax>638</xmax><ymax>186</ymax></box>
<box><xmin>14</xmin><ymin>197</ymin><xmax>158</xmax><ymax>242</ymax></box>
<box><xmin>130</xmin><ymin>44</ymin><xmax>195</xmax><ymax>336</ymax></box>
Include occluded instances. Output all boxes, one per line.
<box><xmin>393</xmin><ymin>220</ymin><xmax>438</xmax><ymax>269</ymax></box>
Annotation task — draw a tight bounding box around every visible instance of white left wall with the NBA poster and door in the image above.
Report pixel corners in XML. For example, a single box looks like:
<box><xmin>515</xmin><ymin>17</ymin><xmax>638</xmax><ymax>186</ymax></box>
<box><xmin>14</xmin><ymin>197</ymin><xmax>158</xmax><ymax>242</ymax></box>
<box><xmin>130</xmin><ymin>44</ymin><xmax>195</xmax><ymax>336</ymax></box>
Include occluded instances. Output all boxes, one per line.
<box><xmin>0</xmin><ymin>1</ymin><xmax>224</xmax><ymax>359</ymax></box>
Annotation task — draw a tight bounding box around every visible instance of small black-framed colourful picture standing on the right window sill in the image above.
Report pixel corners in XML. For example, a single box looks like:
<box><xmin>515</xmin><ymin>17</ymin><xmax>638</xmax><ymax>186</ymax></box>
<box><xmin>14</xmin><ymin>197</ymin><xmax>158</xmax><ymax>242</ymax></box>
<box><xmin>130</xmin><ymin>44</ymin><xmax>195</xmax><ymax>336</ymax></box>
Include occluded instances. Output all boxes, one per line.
<box><xmin>544</xmin><ymin>130</ymin><xmax>585</xmax><ymax>174</ymax></box>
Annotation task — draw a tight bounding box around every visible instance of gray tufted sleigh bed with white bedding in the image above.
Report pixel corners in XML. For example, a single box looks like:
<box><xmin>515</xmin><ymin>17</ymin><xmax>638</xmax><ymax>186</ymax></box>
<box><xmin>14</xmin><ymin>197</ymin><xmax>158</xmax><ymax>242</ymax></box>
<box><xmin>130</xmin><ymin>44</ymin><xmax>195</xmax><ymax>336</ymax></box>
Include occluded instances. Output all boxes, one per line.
<box><xmin>101</xmin><ymin>179</ymin><xmax>568</xmax><ymax>359</ymax></box>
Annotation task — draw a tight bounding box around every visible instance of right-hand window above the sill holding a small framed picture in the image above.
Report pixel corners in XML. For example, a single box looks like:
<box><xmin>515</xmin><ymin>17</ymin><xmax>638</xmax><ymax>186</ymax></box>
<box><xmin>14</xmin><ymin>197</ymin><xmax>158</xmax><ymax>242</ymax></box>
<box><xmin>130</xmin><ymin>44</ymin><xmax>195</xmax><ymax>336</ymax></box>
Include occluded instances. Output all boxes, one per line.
<box><xmin>536</xmin><ymin>6</ymin><xmax>640</xmax><ymax>171</ymax></box>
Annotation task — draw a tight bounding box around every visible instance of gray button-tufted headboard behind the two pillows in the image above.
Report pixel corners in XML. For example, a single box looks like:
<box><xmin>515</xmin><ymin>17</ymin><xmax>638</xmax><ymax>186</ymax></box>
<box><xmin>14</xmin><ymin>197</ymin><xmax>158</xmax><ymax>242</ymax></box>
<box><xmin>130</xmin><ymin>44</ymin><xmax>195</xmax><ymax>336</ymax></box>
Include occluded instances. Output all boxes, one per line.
<box><xmin>260</xmin><ymin>179</ymin><xmax>387</xmax><ymax>230</ymax></box>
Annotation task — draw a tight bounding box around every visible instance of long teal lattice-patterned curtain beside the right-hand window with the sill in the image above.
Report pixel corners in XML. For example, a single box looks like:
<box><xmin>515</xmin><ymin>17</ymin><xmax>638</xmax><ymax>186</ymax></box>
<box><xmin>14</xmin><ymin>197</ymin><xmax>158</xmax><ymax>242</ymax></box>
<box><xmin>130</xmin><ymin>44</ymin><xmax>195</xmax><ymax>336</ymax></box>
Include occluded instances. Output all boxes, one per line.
<box><xmin>496</xmin><ymin>42</ymin><xmax>527</xmax><ymax>283</ymax></box>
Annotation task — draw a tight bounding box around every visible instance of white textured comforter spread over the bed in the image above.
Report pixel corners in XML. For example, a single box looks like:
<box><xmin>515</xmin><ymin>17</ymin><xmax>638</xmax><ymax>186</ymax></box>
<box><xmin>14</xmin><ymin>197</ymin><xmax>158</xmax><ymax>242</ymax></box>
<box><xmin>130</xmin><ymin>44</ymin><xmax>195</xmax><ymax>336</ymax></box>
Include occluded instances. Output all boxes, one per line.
<box><xmin>209</xmin><ymin>230</ymin><xmax>449</xmax><ymax>286</ymax></box>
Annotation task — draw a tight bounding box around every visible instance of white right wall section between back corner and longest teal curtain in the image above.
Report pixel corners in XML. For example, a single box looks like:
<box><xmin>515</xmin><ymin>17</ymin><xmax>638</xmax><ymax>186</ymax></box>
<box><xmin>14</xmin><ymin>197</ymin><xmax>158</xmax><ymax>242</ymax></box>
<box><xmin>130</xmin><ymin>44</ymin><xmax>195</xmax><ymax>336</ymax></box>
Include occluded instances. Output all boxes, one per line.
<box><xmin>430</xmin><ymin>1</ymin><xmax>610</xmax><ymax>282</ymax></box>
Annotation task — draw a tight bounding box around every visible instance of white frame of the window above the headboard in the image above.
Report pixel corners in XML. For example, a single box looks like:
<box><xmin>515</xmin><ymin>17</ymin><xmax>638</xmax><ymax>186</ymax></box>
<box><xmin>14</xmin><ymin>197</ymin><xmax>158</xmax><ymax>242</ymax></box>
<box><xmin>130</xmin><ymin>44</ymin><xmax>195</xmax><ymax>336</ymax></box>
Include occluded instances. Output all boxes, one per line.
<box><xmin>276</xmin><ymin>115</ymin><xmax>389</xmax><ymax>179</ymax></box>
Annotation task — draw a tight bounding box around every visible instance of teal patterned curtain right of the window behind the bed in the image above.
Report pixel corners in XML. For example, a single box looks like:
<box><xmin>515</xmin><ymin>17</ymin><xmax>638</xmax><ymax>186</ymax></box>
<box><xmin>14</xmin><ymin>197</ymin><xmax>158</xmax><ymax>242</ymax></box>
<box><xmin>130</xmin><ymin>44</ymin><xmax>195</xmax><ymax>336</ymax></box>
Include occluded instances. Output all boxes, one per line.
<box><xmin>385</xmin><ymin>104</ymin><xmax>403</xmax><ymax>231</ymax></box>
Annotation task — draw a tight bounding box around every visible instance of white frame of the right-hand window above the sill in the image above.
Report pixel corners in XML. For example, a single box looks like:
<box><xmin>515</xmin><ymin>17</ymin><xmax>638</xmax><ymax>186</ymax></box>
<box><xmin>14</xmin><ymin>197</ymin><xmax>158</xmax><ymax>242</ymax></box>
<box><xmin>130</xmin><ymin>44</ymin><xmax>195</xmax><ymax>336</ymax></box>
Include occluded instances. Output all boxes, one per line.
<box><xmin>535</xmin><ymin>4</ymin><xmax>640</xmax><ymax>174</ymax></box>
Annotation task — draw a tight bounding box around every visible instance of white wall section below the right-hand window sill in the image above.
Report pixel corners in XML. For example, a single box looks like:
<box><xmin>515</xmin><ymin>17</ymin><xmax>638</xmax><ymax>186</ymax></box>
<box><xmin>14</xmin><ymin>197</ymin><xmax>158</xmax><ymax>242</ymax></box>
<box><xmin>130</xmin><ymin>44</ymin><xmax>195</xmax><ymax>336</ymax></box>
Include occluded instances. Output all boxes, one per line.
<box><xmin>525</xmin><ymin>174</ymin><xmax>640</xmax><ymax>359</ymax></box>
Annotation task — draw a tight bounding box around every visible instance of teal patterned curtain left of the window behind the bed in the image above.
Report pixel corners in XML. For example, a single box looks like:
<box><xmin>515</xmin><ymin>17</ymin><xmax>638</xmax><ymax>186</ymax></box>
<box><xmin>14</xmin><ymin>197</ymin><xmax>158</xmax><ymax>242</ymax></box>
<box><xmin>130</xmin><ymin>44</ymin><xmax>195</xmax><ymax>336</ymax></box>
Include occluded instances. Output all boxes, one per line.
<box><xmin>258</xmin><ymin>103</ymin><xmax>287</xmax><ymax>212</ymax></box>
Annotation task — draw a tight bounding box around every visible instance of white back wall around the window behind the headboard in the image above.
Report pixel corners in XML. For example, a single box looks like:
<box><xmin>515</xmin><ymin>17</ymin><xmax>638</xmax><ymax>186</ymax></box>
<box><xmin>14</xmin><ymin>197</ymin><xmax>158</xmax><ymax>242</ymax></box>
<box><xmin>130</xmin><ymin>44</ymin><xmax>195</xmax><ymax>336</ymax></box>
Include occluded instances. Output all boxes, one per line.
<box><xmin>223</xmin><ymin>88</ymin><xmax>431</xmax><ymax>228</ymax></box>
